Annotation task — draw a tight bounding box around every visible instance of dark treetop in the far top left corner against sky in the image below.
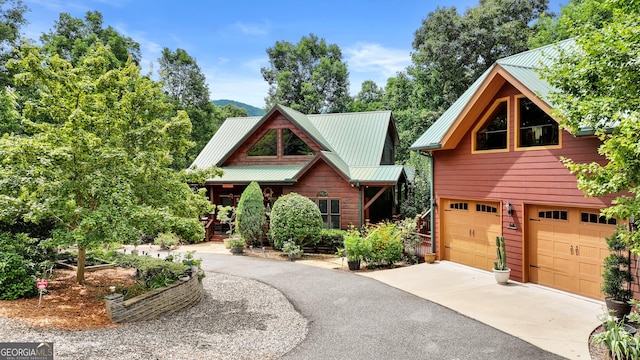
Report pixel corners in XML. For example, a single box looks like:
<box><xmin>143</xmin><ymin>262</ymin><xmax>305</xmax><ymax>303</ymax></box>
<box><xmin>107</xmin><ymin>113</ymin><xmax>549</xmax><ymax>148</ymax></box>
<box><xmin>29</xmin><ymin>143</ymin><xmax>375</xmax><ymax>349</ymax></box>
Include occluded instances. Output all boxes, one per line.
<box><xmin>0</xmin><ymin>0</ymin><xmax>28</xmax><ymax>87</ymax></box>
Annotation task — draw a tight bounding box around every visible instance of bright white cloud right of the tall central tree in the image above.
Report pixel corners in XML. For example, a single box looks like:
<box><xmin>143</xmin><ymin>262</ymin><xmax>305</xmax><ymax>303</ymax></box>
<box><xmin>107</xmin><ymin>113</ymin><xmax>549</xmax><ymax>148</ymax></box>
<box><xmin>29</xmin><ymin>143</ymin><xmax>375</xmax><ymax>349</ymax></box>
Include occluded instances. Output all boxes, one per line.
<box><xmin>344</xmin><ymin>43</ymin><xmax>411</xmax><ymax>78</ymax></box>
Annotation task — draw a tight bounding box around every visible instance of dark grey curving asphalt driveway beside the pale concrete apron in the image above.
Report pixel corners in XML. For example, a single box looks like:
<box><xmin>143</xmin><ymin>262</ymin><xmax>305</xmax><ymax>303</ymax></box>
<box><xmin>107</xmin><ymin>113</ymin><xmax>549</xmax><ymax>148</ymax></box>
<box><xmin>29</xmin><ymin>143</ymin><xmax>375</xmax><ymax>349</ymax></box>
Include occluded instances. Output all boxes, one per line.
<box><xmin>198</xmin><ymin>253</ymin><xmax>561</xmax><ymax>360</ymax></box>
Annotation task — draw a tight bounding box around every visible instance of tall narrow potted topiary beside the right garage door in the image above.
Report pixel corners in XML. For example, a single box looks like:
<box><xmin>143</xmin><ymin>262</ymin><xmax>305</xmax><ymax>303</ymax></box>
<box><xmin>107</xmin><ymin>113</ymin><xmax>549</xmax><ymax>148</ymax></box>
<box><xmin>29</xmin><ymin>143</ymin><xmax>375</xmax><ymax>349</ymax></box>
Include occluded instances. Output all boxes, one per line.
<box><xmin>602</xmin><ymin>227</ymin><xmax>633</xmax><ymax>319</ymax></box>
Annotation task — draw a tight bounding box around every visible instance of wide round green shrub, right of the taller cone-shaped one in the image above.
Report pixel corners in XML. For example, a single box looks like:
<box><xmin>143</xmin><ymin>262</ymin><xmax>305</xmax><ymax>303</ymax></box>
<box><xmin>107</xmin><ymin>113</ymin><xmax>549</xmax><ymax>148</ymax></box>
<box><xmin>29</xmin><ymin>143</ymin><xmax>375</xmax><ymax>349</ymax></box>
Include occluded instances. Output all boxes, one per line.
<box><xmin>269</xmin><ymin>193</ymin><xmax>322</xmax><ymax>250</ymax></box>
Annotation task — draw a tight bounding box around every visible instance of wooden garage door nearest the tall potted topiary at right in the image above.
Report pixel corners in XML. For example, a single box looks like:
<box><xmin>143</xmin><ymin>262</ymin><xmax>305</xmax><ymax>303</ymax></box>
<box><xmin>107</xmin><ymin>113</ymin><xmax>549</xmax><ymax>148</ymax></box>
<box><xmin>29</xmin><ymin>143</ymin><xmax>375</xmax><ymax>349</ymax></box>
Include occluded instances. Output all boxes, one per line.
<box><xmin>528</xmin><ymin>206</ymin><xmax>616</xmax><ymax>299</ymax></box>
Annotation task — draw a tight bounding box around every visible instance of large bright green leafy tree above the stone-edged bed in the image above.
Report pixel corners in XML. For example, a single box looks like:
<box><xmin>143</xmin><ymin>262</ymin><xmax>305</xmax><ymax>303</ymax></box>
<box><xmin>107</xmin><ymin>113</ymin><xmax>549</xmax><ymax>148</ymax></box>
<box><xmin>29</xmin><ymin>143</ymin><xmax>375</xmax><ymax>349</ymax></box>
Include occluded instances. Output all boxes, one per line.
<box><xmin>0</xmin><ymin>42</ymin><xmax>216</xmax><ymax>283</ymax></box>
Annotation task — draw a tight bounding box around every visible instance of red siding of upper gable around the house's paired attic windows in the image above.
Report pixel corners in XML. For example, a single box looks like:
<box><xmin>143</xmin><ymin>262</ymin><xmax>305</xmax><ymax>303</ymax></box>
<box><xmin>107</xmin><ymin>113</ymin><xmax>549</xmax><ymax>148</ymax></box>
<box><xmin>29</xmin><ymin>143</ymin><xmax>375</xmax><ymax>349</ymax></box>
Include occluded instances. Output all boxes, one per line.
<box><xmin>222</xmin><ymin>112</ymin><xmax>323</xmax><ymax>166</ymax></box>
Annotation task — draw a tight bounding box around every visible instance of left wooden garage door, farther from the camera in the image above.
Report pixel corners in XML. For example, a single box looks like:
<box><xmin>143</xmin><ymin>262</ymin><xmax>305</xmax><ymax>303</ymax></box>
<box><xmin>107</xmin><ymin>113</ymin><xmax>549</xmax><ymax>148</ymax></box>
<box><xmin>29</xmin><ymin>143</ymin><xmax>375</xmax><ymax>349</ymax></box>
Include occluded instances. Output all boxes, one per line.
<box><xmin>441</xmin><ymin>199</ymin><xmax>501</xmax><ymax>270</ymax></box>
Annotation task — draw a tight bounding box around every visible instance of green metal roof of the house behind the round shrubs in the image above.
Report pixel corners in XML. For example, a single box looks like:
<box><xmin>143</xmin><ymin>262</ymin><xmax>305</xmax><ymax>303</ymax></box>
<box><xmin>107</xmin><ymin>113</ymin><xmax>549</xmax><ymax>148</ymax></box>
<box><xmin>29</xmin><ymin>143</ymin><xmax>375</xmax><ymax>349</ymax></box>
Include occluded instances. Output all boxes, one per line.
<box><xmin>192</xmin><ymin>105</ymin><xmax>403</xmax><ymax>183</ymax></box>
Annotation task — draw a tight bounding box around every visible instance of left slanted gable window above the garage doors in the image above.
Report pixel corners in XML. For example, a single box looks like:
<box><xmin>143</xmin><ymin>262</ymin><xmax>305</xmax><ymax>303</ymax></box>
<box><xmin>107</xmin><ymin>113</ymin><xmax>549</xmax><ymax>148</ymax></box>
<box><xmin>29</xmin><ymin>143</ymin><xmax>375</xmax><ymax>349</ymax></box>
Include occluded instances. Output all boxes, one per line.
<box><xmin>473</xmin><ymin>99</ymin><xmax>509</xmax><ymax>151</ymax></box>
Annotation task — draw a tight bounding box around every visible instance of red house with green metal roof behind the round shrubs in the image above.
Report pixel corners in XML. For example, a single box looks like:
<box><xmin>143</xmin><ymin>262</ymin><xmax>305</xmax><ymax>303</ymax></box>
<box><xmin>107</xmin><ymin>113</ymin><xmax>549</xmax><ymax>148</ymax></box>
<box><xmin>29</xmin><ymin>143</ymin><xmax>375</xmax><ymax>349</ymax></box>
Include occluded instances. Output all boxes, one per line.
<box><xmin>192</xmin><ymin>105</ymin><xmax>406</xmax><ymax>240</ymax></box>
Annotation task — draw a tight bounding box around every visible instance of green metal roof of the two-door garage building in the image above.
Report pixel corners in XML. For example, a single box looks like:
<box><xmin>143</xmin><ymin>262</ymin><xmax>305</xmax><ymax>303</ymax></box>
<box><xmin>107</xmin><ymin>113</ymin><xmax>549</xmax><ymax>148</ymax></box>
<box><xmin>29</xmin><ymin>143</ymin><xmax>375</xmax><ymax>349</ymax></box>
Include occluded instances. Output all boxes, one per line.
<box><xmin>409</xmin><ymin>39</ymin><xmax>575</xmax><ymax>150</ymax></box>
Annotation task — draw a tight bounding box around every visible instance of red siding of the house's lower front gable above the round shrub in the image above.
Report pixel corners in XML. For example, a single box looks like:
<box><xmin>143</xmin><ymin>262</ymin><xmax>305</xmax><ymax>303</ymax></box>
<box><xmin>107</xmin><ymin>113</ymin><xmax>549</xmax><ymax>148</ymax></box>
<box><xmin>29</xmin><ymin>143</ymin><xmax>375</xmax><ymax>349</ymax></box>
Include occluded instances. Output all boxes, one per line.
<box><xmin>283</xmin><ymin>161</ymin><xmax>360</xmax><ymax>229</ymax></box>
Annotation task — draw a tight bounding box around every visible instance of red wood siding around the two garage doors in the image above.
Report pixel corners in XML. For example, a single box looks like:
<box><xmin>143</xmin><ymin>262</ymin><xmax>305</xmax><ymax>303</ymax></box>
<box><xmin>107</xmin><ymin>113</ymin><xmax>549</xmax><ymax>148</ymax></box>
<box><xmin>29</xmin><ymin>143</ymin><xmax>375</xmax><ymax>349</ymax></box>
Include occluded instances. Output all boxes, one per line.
<box><xmin>433</xmin><ymin>86</ymin><xmax>614</xmax><ymax>281</ymax></box>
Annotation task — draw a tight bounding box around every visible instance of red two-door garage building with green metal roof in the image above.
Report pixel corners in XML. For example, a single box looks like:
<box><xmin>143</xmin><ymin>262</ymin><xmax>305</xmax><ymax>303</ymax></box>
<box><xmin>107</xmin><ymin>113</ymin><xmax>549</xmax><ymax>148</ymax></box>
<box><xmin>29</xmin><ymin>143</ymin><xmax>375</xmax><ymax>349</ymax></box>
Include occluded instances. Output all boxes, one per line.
<box><xmin>410</xmin><ymin>40</ymin><xmax>621</xmax><ymax>299</ymax></box>
